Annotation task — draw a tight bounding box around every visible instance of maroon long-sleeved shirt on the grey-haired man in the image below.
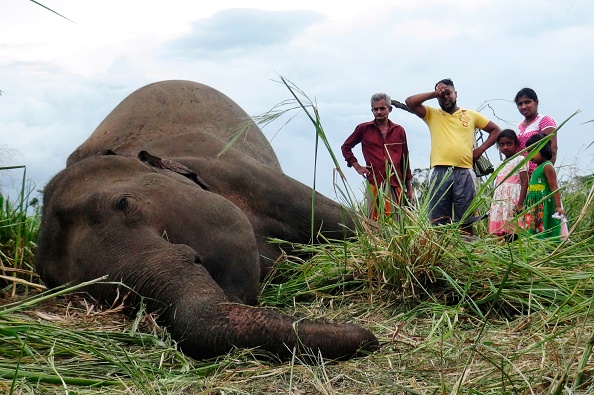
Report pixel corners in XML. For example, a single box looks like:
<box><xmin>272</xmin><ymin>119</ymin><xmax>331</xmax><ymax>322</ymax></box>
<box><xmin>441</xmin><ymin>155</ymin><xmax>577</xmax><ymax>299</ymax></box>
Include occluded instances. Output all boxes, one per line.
<box><xmin>341</xmin><ymin>120</ymin><xmax>412</xmax><ymax>190</ymax></box>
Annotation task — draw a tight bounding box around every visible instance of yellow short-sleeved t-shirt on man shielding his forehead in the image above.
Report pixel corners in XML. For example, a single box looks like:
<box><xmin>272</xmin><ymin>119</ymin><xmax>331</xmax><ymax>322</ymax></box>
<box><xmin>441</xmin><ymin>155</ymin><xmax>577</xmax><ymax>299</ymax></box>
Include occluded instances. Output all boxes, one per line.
<box><xmin>423</xmin><ymin>106</ymin><xmax>489</xmax><ymax>169</ymax></box>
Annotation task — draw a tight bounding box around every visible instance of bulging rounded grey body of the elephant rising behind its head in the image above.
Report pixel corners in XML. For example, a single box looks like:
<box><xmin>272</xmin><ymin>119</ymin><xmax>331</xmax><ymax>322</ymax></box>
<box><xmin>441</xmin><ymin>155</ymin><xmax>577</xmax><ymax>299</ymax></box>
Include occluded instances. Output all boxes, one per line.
<box><xmin>67</xmin><ymin>80</ymin><xmax>281</xmax><ymax>171</ymax></box>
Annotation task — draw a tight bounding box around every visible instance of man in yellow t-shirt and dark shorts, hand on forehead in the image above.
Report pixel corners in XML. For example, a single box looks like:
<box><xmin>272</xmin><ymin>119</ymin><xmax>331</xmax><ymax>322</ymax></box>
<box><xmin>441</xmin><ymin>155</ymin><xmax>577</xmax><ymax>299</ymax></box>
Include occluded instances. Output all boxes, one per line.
<box><xmin>406</xmin><ymin>79</ymin><xmax>501</xmax><ymax>235</ymax></box>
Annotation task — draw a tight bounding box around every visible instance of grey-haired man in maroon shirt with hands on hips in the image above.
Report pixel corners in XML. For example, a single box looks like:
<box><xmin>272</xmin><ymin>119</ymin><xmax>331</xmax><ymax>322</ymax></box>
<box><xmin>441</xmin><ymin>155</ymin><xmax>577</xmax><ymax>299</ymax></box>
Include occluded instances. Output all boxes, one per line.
<box><xmin>341</xmin><ymin>93</ymin><xmax>413</xmax><ymax>220</ymax></box>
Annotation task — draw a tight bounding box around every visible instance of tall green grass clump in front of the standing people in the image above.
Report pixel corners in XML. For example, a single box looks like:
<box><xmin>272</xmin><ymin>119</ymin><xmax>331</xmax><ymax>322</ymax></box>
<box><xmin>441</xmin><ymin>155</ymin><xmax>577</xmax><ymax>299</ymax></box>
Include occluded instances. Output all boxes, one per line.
<box><xmin>260</xmin><ymin>78</ymin><xmax>594</xmax><ymax>317</ymax></box>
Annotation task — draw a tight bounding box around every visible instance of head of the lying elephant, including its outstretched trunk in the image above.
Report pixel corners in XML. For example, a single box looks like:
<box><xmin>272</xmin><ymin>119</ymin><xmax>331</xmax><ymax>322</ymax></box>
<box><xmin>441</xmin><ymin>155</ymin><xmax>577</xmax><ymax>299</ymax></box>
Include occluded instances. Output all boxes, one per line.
<box><xmin>36</xmin><ymin>155</ymin><xmax>377</xmax><ymax>358</ymax></box>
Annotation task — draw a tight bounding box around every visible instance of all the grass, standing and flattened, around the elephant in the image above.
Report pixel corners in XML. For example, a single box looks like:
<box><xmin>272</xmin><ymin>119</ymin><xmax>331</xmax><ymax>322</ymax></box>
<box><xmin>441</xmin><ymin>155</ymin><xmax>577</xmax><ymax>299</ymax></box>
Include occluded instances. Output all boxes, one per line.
<box><xmin>0</xmin><ymin>88</ymin><xmax>594</xmax><ymax>395</ymax></box>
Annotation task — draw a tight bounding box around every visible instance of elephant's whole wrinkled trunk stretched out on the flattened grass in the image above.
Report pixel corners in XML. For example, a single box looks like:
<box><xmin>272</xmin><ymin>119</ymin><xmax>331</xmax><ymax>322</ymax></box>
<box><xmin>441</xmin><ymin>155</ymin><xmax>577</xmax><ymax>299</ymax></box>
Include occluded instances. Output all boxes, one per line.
<box><xmin>70</xmin><ymin>241</ymin><xmax>378</xmax><ymax>359</ymax></box>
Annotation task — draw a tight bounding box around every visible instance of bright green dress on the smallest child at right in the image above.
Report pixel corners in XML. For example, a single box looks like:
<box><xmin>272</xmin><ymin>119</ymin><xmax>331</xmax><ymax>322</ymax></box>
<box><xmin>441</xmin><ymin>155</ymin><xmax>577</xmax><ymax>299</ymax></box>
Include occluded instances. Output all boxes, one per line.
<box><xmin>523</xmin><ymin>161</ymin><xmax>561</xmax><ymax>239</ymax></box>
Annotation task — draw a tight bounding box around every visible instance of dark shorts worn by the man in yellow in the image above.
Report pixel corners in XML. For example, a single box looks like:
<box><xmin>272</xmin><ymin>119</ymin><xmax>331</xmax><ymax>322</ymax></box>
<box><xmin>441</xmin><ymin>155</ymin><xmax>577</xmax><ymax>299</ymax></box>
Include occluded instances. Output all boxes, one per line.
<box><xmin>429</xmin><ymin>166</ymin><xmax>476</xmax><ymax>225</ymax></box>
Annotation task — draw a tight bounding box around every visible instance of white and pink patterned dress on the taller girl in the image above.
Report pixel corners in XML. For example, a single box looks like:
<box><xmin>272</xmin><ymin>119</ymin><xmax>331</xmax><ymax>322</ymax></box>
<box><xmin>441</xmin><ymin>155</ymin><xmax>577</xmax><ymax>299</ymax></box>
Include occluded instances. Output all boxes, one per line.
<box><xmin>489</xmin><ymin>156</ymin><xmax>528</xmax><ymax>236</ymax></box>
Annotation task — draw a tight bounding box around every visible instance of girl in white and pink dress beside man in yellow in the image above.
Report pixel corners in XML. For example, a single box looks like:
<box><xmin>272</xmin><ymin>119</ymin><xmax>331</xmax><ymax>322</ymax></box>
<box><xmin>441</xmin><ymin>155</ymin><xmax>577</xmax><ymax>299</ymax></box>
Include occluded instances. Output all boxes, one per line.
<box><xmin>489</xmin><ymin>129</ymin><xmax>528</xmax><ymax>240</ymax></box>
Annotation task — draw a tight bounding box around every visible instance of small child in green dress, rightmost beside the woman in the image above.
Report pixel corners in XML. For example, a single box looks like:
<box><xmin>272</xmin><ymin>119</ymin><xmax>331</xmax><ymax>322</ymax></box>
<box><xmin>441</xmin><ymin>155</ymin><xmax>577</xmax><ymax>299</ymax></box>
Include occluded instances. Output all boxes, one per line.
<box><xmin>524</xmin><ymin>133</ymin><xmax>565</xmax><ymax>239</ymax></box>
